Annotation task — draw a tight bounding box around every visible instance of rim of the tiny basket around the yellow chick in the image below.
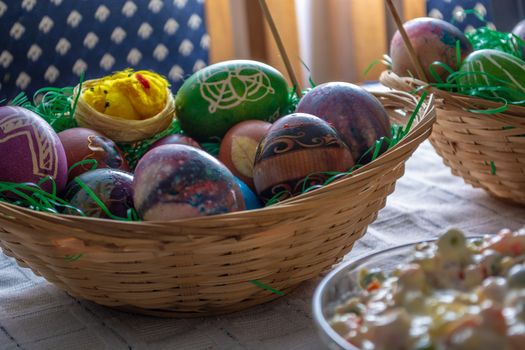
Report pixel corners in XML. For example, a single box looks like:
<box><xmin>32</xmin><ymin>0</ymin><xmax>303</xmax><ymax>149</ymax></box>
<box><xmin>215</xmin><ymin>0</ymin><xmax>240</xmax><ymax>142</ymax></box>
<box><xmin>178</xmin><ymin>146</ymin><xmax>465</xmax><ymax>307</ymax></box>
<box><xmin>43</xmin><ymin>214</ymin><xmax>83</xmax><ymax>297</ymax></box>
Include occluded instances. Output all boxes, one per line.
<box><xmin>73</xmin><ymin>79</ymin><xmax>175</xmax><ymax>128</ymax></box>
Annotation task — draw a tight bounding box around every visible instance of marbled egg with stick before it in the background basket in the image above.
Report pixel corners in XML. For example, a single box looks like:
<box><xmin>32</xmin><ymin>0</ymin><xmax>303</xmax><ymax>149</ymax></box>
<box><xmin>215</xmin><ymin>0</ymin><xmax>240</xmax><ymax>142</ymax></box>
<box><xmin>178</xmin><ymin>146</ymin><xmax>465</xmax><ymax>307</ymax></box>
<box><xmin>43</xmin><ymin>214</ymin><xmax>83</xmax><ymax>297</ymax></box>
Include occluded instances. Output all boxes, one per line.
<box><xmin>390</xmin><ymin>17</ymin><xmax>472</xmax><ymax>82</ymax></box>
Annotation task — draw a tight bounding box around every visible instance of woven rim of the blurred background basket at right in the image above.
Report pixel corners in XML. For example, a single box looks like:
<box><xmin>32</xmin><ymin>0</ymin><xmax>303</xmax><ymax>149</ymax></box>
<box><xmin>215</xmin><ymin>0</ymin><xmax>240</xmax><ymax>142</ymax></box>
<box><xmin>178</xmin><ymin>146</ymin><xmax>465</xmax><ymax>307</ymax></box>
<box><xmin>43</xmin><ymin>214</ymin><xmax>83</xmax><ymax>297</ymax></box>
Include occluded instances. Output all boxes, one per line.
<box><xmin>379</xmin><ymin>70</ymin><xmax>525</xmax><ymax>122</ymax></box>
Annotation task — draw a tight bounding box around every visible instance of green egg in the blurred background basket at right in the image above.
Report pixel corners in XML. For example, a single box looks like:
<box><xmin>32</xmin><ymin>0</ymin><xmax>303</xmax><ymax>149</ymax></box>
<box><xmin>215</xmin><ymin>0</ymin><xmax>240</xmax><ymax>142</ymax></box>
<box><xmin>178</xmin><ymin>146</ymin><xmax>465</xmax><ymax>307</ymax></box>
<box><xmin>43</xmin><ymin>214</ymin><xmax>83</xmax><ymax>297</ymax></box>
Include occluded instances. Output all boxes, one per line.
<box><xmin>458</xmin><ymin>49</ymin><xmax>525</xmax><ymax>102</ymax></box>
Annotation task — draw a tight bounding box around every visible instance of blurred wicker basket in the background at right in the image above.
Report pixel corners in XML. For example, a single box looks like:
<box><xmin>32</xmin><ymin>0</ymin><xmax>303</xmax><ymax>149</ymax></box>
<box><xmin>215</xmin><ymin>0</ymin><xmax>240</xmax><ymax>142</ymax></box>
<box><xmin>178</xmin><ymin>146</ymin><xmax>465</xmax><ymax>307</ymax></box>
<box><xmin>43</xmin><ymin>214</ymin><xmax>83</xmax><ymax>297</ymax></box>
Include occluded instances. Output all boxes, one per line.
<box><xmin>380</xmin><ymin>72</ymin><xmax>525</xmax><ymax>204</ymax></box>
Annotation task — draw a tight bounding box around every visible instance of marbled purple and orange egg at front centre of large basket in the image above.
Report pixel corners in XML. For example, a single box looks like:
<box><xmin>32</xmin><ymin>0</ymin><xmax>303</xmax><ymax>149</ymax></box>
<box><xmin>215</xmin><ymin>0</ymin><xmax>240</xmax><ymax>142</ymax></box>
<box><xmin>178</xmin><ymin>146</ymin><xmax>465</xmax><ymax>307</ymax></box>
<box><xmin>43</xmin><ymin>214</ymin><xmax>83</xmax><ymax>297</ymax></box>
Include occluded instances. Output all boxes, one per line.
<box><xmin>133</xmin><ymin>145</ymin><xmax>244</xmax><ymax>220</ymax></box>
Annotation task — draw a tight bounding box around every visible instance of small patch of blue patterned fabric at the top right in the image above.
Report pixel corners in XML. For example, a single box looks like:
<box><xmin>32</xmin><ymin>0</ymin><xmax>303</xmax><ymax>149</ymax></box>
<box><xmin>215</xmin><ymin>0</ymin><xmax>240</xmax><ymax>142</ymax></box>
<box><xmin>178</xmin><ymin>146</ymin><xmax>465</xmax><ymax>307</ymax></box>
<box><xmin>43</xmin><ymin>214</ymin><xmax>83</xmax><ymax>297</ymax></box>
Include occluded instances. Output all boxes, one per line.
<box><xmin>427</xmin><ymin>0</ymin><xmax>493</xmax><ymax>31</ymax></box>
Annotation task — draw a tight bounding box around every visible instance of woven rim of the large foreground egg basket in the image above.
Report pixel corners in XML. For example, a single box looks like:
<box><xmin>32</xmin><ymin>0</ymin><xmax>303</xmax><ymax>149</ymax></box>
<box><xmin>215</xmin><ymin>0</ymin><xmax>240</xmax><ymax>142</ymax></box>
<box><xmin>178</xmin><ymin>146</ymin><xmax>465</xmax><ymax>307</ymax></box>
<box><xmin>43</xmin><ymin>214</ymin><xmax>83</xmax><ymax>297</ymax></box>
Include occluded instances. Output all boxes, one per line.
<box><xmin>0</xmin><ymin>91</ymin><xmax>436</xmax><ymax>235</ymax></box>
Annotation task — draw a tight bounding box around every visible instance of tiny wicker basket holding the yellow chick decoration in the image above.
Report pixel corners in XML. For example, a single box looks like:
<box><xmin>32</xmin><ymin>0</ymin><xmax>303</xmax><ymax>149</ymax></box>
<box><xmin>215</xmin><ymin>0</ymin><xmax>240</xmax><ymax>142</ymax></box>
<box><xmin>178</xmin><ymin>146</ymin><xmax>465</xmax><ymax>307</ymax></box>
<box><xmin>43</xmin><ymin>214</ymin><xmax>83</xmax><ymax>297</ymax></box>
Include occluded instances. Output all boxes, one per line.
<box><xmin>74</xmin><ymin>79</ymin><xmax>175</xmax><ymax>142</ymax></box>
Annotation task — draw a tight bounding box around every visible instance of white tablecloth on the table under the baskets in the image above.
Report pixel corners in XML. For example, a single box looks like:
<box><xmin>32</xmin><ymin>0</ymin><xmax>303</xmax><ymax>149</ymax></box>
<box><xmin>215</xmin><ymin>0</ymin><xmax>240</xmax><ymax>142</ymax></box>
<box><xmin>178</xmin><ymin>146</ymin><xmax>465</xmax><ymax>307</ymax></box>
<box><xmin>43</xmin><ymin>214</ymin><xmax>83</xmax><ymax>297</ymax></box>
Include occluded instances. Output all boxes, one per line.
<box><xmin>0</xmin><ymin>142</ymin><xmax>525</xmax><ymax>350</ymax></box>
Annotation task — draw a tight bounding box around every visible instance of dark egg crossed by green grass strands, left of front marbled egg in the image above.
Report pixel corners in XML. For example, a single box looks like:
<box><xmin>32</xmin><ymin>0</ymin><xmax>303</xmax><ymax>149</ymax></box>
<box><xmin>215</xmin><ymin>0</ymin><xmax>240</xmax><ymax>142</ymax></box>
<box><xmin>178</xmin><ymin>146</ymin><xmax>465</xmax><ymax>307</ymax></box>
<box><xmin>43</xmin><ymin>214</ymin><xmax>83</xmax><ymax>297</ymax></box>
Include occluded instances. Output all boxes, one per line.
<box><xmin>64</xmin><ymin>168</ymin><xmax>133</xmax><ymax>218</ymax></box>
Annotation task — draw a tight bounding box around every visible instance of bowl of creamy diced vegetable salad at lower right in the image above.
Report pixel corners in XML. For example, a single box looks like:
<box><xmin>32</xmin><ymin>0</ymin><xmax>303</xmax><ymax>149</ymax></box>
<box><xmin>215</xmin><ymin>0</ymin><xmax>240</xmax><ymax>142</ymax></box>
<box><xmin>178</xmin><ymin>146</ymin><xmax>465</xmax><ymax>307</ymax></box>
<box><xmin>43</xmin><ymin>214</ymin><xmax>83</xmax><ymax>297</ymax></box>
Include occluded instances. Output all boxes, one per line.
<box><xmin>314</xmin><ymin>229</ymin><xmax>525</xmax><ymax>350</ymax></box>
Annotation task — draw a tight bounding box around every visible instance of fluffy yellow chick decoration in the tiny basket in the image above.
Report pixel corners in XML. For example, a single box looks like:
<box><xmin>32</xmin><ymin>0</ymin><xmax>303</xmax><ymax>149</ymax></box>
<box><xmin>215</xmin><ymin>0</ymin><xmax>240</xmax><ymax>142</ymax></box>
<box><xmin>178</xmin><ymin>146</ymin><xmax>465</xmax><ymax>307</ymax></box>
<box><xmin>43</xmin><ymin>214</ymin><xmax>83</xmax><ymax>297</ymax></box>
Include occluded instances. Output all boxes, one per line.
<box><xmin>82</xmin><ymin>69</ymin><xmax>169</xmax><ymax>120</ymax></box>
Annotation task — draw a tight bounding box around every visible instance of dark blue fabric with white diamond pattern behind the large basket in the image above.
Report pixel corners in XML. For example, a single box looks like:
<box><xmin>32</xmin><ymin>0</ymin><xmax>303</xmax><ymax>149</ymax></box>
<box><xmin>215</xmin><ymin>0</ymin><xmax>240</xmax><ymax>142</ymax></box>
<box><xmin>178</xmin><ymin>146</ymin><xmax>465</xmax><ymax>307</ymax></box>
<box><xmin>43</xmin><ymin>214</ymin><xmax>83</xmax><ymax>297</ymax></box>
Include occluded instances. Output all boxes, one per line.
<box><xmin>0</xmin><ymin>0</ymin><xmax>209</xmax><ymax>99</ymax></box>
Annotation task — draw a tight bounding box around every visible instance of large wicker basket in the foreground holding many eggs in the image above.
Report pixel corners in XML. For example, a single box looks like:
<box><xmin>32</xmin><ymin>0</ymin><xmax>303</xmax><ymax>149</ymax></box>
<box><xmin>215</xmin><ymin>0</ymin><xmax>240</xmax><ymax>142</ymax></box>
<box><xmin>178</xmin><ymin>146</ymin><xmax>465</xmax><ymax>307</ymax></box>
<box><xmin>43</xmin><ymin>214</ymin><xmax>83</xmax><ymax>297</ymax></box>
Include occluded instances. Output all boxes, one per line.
<box><xmin>0</xmin><ymin>92</ymin><xmax>435</xmax><ymax>317</ymax></box>
